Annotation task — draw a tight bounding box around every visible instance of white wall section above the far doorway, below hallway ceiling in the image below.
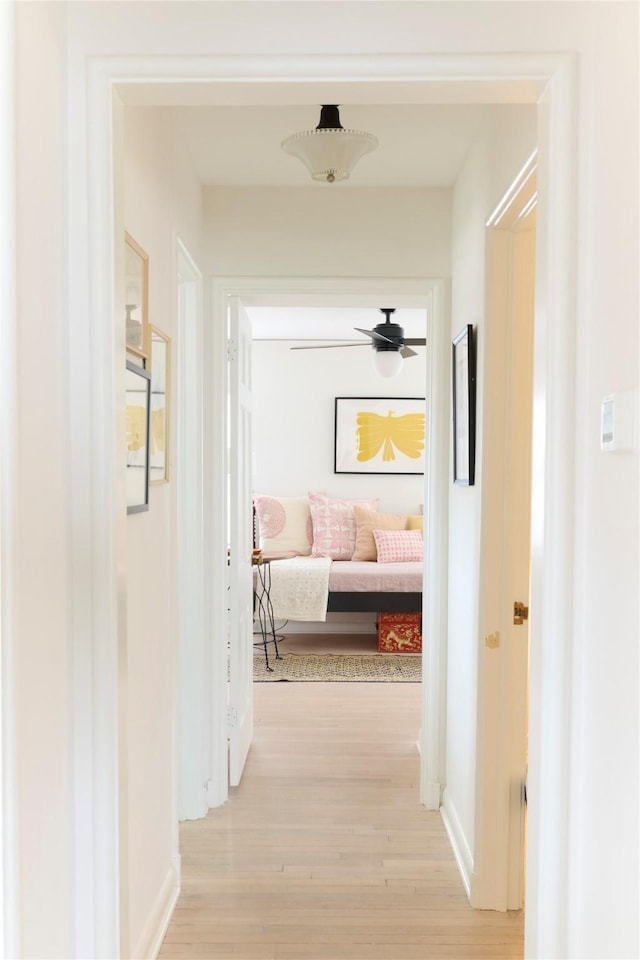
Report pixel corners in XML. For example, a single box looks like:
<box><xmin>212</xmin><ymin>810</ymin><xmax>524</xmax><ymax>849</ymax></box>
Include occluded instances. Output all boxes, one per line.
<box><xmin>204</xmin><ymin>184</ymin><xmax>451</xmax><ymax>277</ymax></box>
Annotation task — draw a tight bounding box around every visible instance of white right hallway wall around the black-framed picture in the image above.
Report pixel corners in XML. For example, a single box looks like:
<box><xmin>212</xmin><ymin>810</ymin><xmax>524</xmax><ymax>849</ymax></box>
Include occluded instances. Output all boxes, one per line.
<box><xmin>445</xmin><ymin>107</ymin><xmax>536</xmax><ymax>873</ymax></box>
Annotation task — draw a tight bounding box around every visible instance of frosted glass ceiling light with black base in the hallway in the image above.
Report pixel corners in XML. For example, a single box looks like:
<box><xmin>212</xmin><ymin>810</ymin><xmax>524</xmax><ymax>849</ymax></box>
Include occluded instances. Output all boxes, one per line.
<box><xmin>282</xmin><ymin>104</ymin><xmax>378</xmax><ymax>183</ymax></box>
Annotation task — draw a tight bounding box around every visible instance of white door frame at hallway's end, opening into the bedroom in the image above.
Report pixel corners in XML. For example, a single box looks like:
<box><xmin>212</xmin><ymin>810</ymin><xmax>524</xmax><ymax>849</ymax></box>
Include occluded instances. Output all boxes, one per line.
<box><xmin>211</xmin><ymin>277</ymin><xmax>450</xmax><ymax>810</ymax></box>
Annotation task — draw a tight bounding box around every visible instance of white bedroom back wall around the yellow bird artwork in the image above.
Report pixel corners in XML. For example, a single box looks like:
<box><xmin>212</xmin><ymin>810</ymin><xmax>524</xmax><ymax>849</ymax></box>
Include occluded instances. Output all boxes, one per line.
<box><xmin>249</xmin><ymin>334</ymin><xmax>427</xmax><ymax>634</ymax></box>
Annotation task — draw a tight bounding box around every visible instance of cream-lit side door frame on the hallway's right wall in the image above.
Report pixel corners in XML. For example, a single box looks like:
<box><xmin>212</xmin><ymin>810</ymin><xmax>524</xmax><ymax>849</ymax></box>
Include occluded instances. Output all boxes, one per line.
<box><xmin>469</xmin><ymin>174</ymin><xmax>537</xmax><ymax>910</ymax></box>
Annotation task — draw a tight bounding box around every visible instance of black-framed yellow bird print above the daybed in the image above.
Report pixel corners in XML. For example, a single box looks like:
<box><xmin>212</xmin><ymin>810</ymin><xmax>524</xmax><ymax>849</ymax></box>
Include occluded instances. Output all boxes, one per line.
<box><xmin>334</xmin><ymin>397</ymin><xmax>426</xmax><ymax>474</ymax></box>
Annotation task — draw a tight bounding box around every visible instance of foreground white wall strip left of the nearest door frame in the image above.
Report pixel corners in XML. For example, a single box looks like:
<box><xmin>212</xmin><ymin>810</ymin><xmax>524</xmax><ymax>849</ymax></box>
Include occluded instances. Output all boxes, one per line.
<box><xmin>11</xmin><ymin>4</ymin><xmax>73</xmax><ymax>957</ymax></box>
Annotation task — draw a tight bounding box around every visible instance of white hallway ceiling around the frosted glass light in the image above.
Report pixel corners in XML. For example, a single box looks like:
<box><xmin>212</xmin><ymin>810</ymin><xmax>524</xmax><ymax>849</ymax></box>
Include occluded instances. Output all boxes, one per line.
<box><xmin>165</xmin><ymin>104</ymin><xmax>489</xmax><ymax>190</ymax></box>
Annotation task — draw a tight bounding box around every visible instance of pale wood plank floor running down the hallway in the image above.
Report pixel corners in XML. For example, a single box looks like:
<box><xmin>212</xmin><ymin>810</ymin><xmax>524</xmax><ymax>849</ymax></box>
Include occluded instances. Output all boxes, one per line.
<box><xmin>160</xmin><ymin>683</ymin><xmax>523</xmax><ymax>960</ymax></box>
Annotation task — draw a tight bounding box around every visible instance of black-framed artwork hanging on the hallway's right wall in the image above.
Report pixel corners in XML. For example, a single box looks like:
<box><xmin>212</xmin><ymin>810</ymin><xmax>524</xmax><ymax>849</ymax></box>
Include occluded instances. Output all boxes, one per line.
<box><xmin>452</xmin><ymin>324</ymin><xmax>476</xmax><ymax>487</ymax></box>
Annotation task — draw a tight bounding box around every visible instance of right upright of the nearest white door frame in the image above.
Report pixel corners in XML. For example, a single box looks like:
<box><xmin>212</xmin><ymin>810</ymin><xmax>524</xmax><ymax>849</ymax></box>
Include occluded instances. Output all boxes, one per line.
<box><xmin>525</xmin><ymin>55</ymin><xmax>578</xmax><ymax>957</ymax></box>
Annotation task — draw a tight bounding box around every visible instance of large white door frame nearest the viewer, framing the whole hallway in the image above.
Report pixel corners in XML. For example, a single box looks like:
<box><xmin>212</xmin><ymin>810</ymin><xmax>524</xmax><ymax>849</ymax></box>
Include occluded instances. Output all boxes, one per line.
<box><xmin>69</xmin><ymin>48</ymin><xmax>578</xmax><ymax>956</ymax></box>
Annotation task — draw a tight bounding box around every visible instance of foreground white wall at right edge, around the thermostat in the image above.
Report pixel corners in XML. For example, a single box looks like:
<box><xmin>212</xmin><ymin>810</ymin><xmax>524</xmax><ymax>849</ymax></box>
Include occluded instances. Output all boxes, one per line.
<box><xmin>567</xmin><ymin>3</ymin><xmax>640</xmax><ymax>958</ymax></box>
